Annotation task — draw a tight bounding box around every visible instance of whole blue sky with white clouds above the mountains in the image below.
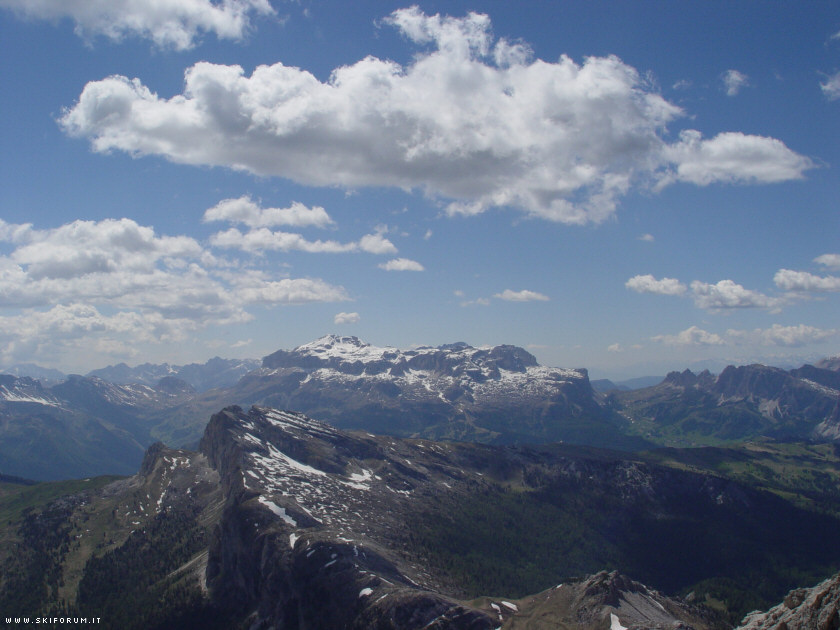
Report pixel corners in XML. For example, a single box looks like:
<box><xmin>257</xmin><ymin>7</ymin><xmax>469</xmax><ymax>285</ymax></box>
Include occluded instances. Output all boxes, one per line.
<box><xmin>0</xmin><ymin>0</ymin><xmax>840</xmax><ymax>379</ymax></box>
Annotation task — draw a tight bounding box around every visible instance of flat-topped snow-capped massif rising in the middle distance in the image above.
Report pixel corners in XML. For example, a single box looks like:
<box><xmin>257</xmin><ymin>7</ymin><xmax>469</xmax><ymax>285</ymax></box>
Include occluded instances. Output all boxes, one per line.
<box><xmin>223</xmin><ymin>335</ymin><xmax>641</xmax><ymax>446</ymax></box>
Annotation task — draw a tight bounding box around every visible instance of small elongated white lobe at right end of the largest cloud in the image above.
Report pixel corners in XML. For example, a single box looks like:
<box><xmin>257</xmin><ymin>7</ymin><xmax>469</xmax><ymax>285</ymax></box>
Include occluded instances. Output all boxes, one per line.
<box><xmin>658</xmin><ymin>130</ymin><xmax>813</xmax><ymax>188</ymax></box>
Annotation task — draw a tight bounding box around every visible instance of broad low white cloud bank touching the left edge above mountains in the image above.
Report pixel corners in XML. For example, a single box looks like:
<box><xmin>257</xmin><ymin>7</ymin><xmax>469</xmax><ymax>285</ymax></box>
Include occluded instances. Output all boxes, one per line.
<box><xmin>0</xmin><ymin>219</ymin><xmax>348</xmax><ymax>366</ymax></box>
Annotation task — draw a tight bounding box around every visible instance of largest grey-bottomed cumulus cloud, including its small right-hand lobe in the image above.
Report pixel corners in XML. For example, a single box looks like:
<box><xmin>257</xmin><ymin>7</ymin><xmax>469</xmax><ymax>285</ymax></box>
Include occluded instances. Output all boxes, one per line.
<box><xmin>60</xmin><ymin>7</ymin><xmax>812</xmax><ymax>224</ymax></box>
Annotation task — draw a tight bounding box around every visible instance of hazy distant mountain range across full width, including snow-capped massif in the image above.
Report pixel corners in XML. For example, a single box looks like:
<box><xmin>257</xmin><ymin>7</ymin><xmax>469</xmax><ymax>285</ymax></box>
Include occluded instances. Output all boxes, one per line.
<box><xmin>0</xmin><ymin>335</ymin><xmax>840</xmax><ymax>479</ymax></box>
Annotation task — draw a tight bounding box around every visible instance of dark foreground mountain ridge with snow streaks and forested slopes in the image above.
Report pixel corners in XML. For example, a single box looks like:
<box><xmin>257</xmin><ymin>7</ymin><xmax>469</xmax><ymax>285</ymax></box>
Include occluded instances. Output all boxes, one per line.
<box><xmin>0</xmin><ymin>407</ymin><xmax>840</xmax><ymax>630</ymax></box>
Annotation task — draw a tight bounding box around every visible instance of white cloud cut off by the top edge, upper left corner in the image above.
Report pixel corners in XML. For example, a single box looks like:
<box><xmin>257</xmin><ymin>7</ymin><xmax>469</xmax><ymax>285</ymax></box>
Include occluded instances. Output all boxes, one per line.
<box><xmin>0</xmin><ymin>0</ymin><xmax>274</xmax><ymax>50</ymax></box>
